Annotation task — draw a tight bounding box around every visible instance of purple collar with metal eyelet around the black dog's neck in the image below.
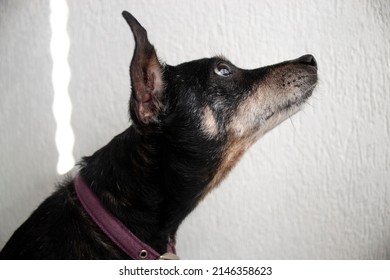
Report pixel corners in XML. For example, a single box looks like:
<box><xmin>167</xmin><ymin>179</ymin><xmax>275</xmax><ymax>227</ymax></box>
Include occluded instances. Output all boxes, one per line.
<box><xmin>74</xmin><ymin>175</ymin><xmax>179</xmax><ymax>260</ymax></box>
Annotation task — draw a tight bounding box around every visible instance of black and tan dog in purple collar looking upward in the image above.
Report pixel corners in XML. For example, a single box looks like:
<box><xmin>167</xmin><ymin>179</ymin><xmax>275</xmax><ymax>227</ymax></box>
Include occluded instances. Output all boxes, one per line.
<box><xmin>0</xmin><ymin>11</ymin><xmax>317</xmax><ymax>259</ymax></box>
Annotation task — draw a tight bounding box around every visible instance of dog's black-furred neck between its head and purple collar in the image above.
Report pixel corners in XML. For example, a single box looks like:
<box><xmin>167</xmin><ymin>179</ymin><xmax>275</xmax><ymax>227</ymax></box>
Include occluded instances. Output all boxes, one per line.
<box><xmin>80</xmin><ymin>126</ymin><xmax>219</xmax><ymax>253</ymax></box>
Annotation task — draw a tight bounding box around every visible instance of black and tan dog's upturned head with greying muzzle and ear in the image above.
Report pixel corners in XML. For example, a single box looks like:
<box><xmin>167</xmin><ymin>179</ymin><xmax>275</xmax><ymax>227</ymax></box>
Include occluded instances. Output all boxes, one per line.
<box><xmin>123</xmin><ymin>12</ymin><xmax>317</xmax><ymax>197</ymax></box>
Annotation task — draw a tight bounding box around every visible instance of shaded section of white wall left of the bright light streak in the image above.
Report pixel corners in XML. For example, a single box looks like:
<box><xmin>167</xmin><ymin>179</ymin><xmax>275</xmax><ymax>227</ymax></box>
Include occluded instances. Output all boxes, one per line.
<box><xmin>0</xmin><ymin>0</ymin><xmax>59</xmax><ymax>248</ymax></box>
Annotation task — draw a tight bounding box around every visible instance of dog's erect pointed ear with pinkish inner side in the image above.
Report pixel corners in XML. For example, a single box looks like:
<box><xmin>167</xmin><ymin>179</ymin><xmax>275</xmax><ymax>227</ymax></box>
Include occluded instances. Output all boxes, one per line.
<box><xmin>122</xmin><ymin>11</ymin><xmax>164</xmax><ymax>124</ymax></box>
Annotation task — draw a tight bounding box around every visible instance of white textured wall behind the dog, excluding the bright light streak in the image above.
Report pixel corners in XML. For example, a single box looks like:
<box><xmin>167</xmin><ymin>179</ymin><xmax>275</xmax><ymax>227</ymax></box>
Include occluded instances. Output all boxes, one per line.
<box><xmin>0</xmin><ymin>0</ymin><xmax>390</xmax><ymax>259</ymax></box>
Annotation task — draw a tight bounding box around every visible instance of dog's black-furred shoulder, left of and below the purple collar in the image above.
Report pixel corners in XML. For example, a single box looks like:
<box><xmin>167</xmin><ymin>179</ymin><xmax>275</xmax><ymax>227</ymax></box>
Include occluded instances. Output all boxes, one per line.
<box><xmin>0</xmin><ymin>178</ymin><xmax>123</xmax><ymax>259</ymax></box>
